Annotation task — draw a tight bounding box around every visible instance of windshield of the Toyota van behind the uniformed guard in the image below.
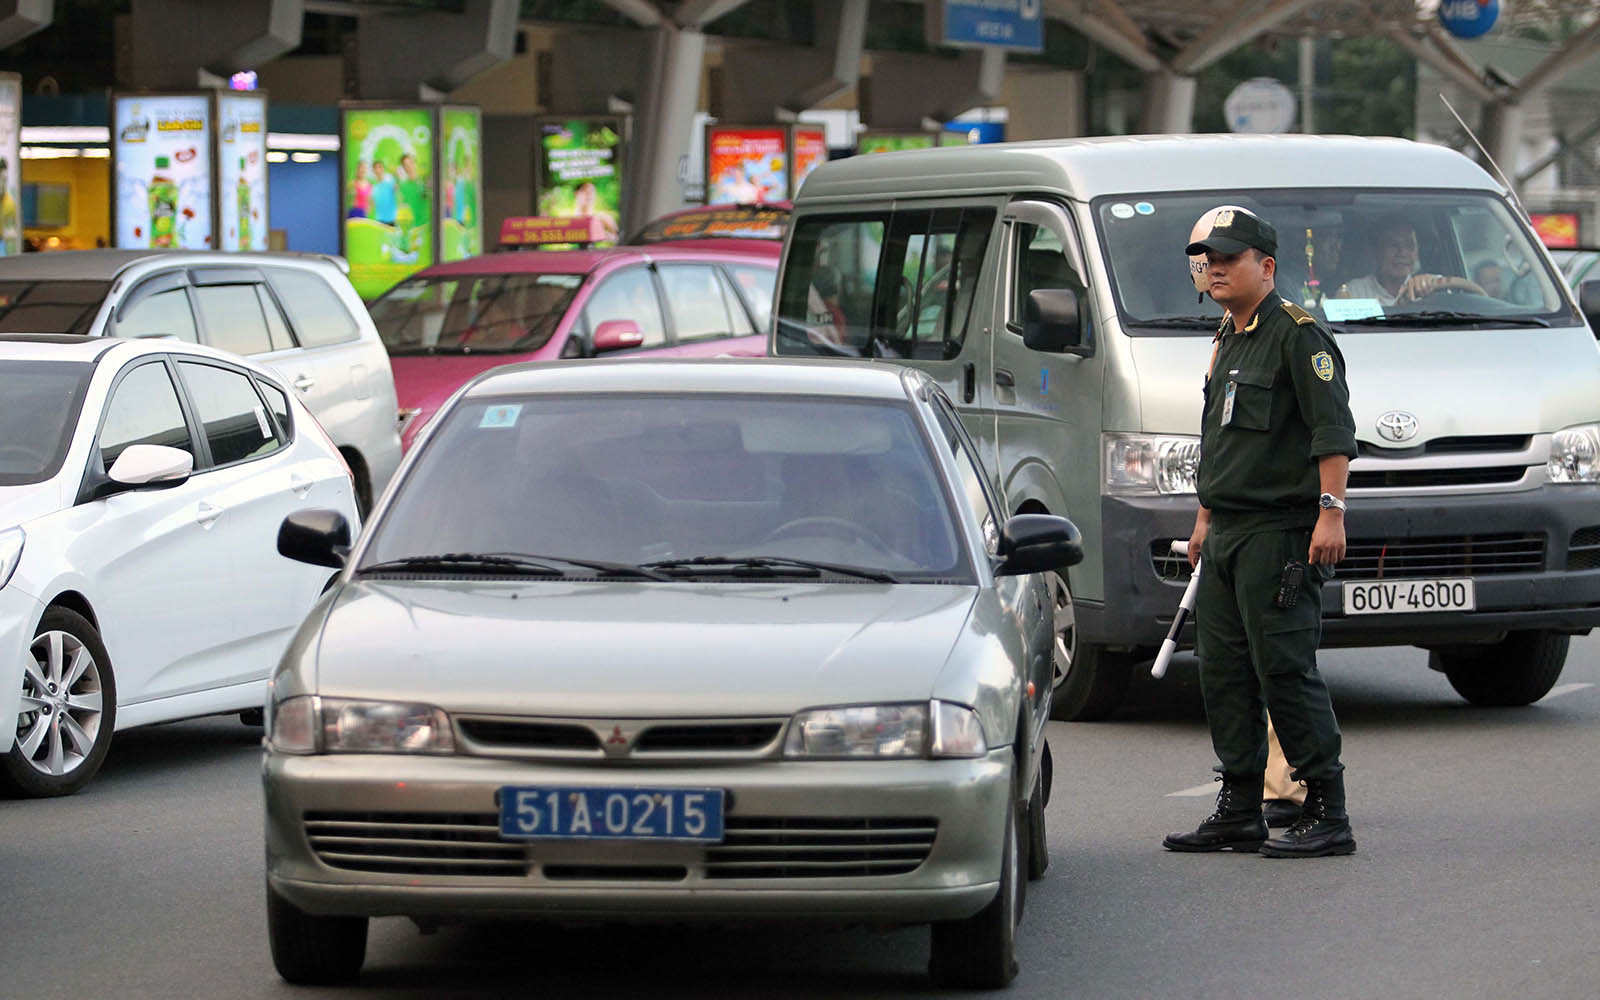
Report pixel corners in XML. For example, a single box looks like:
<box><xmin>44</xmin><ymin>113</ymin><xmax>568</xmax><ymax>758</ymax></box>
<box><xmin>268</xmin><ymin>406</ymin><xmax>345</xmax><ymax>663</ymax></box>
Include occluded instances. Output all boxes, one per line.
<box><xmin>1093</xmin><ymin>189</ymin><xmax>1581</xmax><ymax>336</ymax></box>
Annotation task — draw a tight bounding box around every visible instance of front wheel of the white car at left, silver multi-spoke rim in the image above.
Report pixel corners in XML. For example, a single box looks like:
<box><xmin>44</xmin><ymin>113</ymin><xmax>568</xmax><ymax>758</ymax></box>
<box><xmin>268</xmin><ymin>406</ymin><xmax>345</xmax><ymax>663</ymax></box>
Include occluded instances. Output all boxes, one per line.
<box><xmin>0</xmin><ymin>608</ymin><xmax>117</xmax><ymax>797</ymax></box>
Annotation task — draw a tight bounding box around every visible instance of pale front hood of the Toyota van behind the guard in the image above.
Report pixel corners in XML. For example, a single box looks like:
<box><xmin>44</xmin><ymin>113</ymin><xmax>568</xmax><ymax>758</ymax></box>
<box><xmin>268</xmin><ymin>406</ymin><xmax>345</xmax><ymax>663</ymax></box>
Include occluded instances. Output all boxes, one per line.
<box><xmin>1126</xmin><ymin>326</ymin><xmax>1600</xmax><ymax>438</ymax></box>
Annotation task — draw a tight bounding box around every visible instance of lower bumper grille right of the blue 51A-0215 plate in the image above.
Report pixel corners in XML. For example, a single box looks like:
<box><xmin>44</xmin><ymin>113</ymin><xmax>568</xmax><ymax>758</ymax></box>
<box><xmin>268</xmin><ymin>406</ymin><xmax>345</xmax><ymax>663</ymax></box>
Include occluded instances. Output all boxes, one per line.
<box><xmin>706</xmin><ymin>816</ymin><xmax>939</xmax><ymax>878</ymax></box>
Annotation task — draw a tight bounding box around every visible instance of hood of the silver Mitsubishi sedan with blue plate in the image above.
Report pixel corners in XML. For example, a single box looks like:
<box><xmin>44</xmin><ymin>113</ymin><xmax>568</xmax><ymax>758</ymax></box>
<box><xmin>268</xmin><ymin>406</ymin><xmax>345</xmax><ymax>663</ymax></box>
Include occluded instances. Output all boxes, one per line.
<box><xmin>315</xmin><ymin>581</ymin><xmax>978</xmax><ymax>717</ymax></box>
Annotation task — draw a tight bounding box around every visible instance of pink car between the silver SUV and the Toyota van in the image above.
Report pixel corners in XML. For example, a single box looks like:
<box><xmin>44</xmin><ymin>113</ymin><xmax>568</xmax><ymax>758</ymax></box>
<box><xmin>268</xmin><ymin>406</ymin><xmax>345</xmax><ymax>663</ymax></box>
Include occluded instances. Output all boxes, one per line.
<box><xmin>370</xmin><ymin>240</ymin><xmax>782</xmax><ymax>448</ymax></box>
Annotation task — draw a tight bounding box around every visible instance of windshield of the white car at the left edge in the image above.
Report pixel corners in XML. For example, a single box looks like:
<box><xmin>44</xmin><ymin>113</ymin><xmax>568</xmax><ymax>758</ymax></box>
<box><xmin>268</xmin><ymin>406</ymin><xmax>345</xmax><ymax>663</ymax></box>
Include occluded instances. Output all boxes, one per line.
<box><xmin>0</xmin><ymin>360</ymin><xmax>94</xmax><ymax>486</ymax></box>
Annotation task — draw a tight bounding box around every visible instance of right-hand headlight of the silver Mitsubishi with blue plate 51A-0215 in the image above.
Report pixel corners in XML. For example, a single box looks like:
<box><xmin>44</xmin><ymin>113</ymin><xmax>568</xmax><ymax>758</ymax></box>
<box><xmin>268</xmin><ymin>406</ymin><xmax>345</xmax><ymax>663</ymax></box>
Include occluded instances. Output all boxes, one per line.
<box><xmin>784</xmin><ymin>701</ymin><xmax>989</xmax><ymax>760</ymax></box>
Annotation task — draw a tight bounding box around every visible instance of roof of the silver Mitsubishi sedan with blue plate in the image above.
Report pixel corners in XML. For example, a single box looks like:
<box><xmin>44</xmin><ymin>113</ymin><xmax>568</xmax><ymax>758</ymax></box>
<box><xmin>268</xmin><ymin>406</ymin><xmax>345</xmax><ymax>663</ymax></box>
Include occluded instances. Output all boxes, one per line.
<box><xmin>464</xmin><ymin>358</ymin><xmax>930</xmax><ymax>402</ymax></box>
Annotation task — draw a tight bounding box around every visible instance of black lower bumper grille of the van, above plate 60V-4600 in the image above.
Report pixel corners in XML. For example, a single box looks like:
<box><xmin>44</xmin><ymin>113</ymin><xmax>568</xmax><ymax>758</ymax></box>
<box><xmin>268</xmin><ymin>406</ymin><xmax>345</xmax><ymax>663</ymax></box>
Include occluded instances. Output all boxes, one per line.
<box><xmin>1150</xmin><ymin>526</ymin><xmax>1548</xmax><ymax>582</ymax></box>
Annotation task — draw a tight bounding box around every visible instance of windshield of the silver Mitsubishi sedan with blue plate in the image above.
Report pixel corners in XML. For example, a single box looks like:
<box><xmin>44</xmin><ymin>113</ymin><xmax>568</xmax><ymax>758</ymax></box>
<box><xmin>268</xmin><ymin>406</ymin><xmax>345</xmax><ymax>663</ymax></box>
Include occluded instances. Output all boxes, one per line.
<box><xmin>358</xmin><ymin>394</ymin><xmax>973</xmax><ymax>582</ymax></box>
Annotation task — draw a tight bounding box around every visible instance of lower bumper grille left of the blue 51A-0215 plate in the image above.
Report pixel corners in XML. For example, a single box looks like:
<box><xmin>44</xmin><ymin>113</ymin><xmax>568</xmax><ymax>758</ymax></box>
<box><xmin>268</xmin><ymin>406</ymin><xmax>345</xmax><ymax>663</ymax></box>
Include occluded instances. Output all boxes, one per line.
<box><xmin>306</xmin><ymin>813</ymin><xmax>528</xmax><ymax>875</ymax></box>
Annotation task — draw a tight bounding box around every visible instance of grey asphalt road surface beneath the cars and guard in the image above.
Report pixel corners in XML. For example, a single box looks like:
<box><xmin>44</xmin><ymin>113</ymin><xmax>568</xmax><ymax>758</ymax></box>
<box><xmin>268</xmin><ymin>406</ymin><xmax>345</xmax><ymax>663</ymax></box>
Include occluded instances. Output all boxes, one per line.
<box><xmin>0</xmin><ymin>637</ymin><xmax>1600</xmax><ymax>1000</ymax></box>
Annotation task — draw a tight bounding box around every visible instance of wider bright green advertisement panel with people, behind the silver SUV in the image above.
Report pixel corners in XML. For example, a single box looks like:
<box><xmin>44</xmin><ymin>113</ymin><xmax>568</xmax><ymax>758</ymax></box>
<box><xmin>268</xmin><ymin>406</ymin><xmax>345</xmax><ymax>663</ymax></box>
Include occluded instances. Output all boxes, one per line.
<box><xmin>339</xmin><ymin>107</ymin><xmax>435</xmax><ymax>299</ymax></box>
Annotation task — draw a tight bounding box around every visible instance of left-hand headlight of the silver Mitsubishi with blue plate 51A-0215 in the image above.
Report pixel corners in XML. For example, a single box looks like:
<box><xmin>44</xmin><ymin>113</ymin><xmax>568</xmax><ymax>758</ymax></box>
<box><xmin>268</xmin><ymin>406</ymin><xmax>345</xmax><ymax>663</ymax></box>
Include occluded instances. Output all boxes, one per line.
<box><xmin>270</xmin><ymin>694</ymin><xmax>456</xmax><ymax>754</ymax></box>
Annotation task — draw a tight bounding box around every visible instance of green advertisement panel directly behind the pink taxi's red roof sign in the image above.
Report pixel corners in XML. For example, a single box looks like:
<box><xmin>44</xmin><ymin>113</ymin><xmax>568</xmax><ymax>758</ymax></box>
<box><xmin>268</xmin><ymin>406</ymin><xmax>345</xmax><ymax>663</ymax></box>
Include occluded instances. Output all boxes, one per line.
<box><xmin>534</xmin><ymin>115</ymin><xmax>624</xmax><ymax>242</ymax></box>
